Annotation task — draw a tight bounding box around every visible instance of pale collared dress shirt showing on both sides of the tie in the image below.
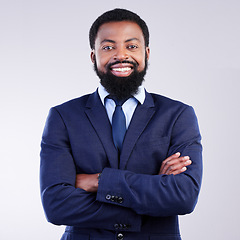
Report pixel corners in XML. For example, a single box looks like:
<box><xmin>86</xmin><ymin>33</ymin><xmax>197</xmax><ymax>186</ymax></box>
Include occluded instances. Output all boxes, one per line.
<box><xmin>98</xmin><ymin>84</ymin><xmax>145</xmax><ymax>129</ymax></box>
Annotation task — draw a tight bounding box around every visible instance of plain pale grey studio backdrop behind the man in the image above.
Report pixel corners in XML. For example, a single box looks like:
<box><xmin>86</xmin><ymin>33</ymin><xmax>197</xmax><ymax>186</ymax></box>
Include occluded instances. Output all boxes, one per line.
<box><xmin>0</xmin><ymin>0</ymin><xmax>240</xmax><ymax>240</ymax></box>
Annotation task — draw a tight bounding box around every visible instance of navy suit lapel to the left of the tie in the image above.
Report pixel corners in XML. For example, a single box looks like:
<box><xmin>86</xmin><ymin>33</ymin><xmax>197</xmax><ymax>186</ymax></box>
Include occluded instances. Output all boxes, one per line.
<box><xmin>85</xmin><ymin>91</ymin><xmax>118</xmax><ymax>168</ymax></box>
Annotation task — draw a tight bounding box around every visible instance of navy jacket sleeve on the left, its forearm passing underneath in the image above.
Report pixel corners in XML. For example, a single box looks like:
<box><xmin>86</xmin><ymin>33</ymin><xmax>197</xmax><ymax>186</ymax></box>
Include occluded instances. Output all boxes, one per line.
<box><xmin>40</xmin><ymin>108</ymin><xmax>141</xmax><ymax>231</ymax></box>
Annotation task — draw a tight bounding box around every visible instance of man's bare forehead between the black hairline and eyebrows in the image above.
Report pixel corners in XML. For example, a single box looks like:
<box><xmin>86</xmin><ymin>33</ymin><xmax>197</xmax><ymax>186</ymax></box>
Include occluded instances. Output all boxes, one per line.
<box><xmin>96</xmin><ymin>21</ymin><xmax>144</xmax><ymax>43</ymax></box>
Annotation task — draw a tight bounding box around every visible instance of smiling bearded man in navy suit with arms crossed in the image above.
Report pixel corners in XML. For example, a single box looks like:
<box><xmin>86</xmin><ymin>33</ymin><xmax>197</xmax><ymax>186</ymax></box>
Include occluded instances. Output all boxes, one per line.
<box><xmin>40</xmin><ymin>9</ymin><xmax>202</xmax><ymax>240</ymax></box>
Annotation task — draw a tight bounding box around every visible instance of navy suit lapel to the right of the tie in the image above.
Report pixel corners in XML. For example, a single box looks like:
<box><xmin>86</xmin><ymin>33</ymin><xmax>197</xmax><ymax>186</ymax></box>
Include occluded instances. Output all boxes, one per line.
<box><xmin>120</xmin><ymin>92</ymin><xmax>155</xmax><ymax>169</ymax></box>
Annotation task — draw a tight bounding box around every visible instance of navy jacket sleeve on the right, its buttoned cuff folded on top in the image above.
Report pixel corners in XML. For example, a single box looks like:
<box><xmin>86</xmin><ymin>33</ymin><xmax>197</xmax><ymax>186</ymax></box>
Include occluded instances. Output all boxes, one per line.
<box><xmin>97</xmin><ymin>106</ymin><xmax>202</xmax><ymax>217</ymax></box>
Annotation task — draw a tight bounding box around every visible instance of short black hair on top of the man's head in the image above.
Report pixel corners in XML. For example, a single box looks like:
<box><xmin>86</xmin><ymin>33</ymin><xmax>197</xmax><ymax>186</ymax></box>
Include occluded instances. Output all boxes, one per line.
<box><xmin>89</xmin><ymin>8</ymin><xmax>149</xmax><ymax>49</ymax></box>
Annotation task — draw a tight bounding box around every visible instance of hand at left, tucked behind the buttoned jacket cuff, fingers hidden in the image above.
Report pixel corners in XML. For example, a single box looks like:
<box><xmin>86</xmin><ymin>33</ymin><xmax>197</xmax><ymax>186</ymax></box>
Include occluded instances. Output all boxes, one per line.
<box><xmin>75</xmin><ymin>173</ymin><xmax>99</xmax><ymax>192</ymax></box>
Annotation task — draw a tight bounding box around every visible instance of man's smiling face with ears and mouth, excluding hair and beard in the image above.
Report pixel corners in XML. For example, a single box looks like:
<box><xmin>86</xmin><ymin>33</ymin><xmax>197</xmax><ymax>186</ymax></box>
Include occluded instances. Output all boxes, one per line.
<box><xmin>91</xmin><ymin>21</ymin><xmax>149</xmax><ymax>77</ymax></box>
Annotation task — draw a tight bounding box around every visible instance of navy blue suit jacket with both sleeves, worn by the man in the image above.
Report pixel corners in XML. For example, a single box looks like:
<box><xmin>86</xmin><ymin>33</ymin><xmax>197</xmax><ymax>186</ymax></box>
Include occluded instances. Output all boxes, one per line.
<box><xmin>40</xmin><ymin>91</ymin><xmax>202</xmax><ymax>240</ymax></box>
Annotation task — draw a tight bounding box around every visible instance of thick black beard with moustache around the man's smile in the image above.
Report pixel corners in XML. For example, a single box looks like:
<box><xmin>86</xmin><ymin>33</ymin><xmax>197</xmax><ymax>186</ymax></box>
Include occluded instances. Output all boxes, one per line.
<box><xmin>94</xmin><ymin>56</ymin><xmax>148</xmax><ymax>100</ymax></box>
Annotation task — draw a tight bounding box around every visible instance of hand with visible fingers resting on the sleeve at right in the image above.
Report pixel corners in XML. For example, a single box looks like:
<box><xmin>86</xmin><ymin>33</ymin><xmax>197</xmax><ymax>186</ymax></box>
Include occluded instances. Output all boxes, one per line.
<box><xmin>158</xmin><ymin>152</ymin><xmax>192</xmax><ymax>175</ymax></box>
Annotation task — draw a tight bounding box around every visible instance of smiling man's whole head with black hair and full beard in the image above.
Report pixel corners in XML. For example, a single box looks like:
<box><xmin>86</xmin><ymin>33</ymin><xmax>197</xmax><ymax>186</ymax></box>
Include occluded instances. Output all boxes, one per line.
<box><xmin>89</xmin><ymin>9</ymin><xmax>149</xmax><ymax>99</ymax></box>
